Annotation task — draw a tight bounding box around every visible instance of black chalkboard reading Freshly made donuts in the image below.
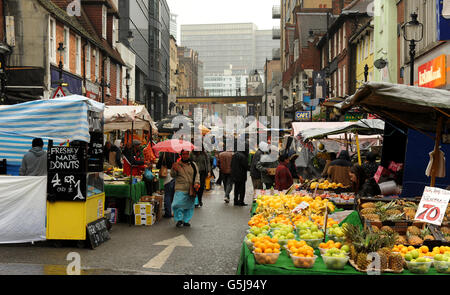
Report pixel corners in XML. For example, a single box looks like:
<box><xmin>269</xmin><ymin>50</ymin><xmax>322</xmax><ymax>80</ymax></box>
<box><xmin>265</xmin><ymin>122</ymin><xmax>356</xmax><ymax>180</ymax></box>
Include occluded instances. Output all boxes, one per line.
<box><xmin>47</xmin><ymin>146</ymin><xmax>87</xmax><ymax>173</ymax></box>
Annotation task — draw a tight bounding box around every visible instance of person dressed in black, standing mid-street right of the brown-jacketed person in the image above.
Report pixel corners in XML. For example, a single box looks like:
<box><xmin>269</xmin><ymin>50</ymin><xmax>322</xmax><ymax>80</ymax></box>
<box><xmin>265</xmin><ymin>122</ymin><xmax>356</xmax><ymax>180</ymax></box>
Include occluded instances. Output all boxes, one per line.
<box><xmin>231</xmin><ymin>151</ymin><xmax>249</xmax><ymax>206</ymax></box>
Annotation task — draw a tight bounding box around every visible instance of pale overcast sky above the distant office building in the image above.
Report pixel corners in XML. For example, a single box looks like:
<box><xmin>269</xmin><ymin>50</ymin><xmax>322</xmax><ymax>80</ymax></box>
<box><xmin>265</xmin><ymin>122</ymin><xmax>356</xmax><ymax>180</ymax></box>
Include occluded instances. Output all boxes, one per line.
<box><xmin>167</xmin><ymin>0</ymin><xmax>280</xmax><ymax>39</ymax></box>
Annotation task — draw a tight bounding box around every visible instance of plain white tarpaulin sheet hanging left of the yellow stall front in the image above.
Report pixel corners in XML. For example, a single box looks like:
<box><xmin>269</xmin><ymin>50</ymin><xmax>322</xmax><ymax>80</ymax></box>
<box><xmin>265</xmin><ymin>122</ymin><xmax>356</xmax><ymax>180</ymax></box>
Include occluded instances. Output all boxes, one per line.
<box><xmin>0</xmin><ymin>176</ymin><xmax>47</xmax><ymax>244</ymax></box>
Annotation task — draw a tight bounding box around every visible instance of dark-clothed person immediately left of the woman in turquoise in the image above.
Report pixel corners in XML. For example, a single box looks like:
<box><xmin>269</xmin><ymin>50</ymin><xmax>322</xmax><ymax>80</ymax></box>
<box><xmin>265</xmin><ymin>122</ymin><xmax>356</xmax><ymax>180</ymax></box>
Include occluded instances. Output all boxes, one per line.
<box><xmin>156</xmin><ymin>152</ymin><xmax>178</xmax><ymax>218</ymax></box>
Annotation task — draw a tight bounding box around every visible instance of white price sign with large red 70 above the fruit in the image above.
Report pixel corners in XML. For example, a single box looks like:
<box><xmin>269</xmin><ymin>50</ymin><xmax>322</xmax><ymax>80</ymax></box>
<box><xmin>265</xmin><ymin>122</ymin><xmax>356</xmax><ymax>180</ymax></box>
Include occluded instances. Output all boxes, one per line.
<box><xmin>414</xmin><ymin>186</ymin><xmax>450</xmax><ymax>226</ymax></box>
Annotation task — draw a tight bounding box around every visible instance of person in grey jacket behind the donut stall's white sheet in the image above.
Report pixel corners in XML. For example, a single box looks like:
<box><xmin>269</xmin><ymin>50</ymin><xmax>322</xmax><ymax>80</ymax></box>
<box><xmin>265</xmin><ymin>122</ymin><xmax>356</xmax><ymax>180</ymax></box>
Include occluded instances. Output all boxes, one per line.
<box><xmin>19</xmin><ymin>138</ymin><xmax>47</xmax><ymax>176</ymax></box>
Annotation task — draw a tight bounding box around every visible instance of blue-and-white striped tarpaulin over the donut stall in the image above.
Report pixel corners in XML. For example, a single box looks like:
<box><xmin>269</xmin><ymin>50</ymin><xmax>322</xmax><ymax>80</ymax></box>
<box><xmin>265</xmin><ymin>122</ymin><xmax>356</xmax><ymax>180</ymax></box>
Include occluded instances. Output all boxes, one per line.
<box><xmin>0</xmin><ymin>95</ymin><xmax>103</xmax><ymax>175</ymax></box>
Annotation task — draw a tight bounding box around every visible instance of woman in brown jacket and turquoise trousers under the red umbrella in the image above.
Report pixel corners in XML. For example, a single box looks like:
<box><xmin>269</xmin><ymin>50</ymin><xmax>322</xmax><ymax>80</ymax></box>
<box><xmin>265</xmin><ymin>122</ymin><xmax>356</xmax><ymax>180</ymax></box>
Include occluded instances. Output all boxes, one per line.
<box><xmin>170</xmin><ymin>150</ymin><xmax>200</xmax><ymax>227</ymax></box>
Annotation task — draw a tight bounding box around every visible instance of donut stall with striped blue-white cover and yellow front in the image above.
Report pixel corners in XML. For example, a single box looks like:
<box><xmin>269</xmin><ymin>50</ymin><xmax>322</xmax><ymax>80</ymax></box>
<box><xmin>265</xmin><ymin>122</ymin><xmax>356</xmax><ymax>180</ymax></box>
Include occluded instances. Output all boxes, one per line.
<box><xmin>0</xmin><ymin>95</ymin><xmax>109</xmax><ymax>247</ymax></box>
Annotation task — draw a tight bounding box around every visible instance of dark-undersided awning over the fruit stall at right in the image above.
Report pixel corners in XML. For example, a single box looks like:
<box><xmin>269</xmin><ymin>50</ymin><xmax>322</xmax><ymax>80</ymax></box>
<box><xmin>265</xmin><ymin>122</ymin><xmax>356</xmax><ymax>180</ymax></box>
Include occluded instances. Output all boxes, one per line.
<box><xmin>336</xmin><ymin>82</ymin><xmax>450</xmax><ymax>133</ymax></box>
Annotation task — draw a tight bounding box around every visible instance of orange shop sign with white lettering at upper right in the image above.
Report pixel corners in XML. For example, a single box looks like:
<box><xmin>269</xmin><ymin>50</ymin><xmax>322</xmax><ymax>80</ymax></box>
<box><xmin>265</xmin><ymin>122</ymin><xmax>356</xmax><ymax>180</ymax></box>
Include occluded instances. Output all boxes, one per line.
<box><xmin>419</xmin><ymin>55</ymin><xmax>447</xmax><ymax>88</ymax></box>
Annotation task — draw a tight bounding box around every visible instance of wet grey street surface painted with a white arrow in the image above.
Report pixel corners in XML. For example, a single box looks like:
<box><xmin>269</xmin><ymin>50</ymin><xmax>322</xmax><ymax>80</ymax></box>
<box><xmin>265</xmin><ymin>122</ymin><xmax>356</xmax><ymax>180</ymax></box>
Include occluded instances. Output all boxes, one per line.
<box><xmin>0</xmin><ymin>178</ymin><xmax>253</xmax><ymax>275</ymax></box>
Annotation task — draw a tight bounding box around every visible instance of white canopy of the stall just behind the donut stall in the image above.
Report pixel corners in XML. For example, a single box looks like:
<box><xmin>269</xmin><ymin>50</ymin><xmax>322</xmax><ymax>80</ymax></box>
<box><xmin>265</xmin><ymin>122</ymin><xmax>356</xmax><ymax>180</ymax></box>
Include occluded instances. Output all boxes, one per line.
<box><xmin>104</xmin><ymin>106</ymin><xmax>158</xmax><ymax>134</ymax></box>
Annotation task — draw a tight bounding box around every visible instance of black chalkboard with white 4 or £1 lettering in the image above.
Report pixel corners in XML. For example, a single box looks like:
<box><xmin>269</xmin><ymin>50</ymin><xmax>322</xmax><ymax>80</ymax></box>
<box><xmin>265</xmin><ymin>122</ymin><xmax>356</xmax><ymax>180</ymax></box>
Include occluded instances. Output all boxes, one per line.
<box><xmin>47</xmin><ymin>172</ymin><xmax>87</xmax><ymax>202</ymax></box>
